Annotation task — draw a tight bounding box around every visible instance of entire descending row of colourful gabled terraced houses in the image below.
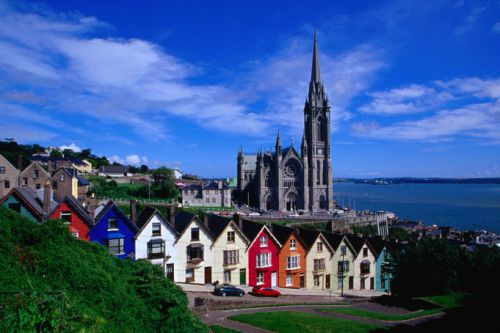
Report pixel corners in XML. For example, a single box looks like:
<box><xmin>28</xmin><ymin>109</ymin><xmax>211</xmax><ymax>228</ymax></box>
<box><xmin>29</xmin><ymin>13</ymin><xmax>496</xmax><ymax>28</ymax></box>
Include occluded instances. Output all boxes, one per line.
<box><xmin>0</xmin><ymin>180</ymin><xmax>390</xmax><ymax>291</ymax></box>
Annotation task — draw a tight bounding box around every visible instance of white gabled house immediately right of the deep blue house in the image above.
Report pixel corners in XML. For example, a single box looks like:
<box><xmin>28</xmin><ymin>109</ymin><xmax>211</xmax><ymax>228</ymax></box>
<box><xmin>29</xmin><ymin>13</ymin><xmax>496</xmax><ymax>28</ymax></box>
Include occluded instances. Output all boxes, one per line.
<box><xmin>135</xmin><ymin>206</ymin><xmax>178</xmax><ymax>280</ymax></box>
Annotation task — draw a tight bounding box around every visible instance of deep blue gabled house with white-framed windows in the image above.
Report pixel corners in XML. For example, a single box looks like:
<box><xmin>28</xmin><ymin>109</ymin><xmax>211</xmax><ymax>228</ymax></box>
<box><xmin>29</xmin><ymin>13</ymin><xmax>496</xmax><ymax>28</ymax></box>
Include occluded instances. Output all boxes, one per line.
<box><xmin>90</xmin><ymin>200</ymin><xmax>138</xmax><ymax>259</ymax></box>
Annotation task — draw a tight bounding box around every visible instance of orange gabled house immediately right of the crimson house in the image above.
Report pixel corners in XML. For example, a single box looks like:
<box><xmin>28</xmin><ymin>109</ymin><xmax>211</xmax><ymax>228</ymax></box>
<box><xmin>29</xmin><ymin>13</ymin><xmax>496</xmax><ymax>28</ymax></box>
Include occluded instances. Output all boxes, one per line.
<box><xmin>271</xmin><ymin>225</ymin><xmax>306</xmax><ymax>288</ymax></box>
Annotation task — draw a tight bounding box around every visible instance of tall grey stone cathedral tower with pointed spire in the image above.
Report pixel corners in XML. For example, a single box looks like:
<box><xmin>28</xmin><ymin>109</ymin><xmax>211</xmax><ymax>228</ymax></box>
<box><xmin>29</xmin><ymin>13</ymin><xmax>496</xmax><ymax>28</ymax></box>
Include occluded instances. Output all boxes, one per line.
<box><xmin>302</xmin><ymin>33</ymin><xmax>335</xmax><ymax>210</ymax></box>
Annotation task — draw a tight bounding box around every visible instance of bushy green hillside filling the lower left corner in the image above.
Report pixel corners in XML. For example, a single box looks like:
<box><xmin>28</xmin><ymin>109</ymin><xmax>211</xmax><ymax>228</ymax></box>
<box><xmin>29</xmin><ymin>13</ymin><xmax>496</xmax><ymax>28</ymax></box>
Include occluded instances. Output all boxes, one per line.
<box><xmin>0</xmin><ymin>207</ymin><xmax>208</xmax><ymax>332</ymax></box>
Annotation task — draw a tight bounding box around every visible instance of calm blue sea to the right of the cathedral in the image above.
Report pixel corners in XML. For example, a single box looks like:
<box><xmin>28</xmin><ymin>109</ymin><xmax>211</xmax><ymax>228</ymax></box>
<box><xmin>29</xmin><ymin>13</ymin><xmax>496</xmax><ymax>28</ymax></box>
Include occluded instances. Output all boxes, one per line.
<box><xmin>333</xmin><ymin>182</ymin><xmax>500</xmax><ymax>234</ymax></box>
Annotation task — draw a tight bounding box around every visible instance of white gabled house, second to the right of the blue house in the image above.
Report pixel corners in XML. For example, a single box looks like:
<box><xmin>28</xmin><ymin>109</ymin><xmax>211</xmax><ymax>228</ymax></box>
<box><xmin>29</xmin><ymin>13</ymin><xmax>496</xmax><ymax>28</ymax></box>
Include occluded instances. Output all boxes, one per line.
<box><xmin>173</xmin><ymin>211</ymin><xmax>214</xmax><ymax>284</ymax></box>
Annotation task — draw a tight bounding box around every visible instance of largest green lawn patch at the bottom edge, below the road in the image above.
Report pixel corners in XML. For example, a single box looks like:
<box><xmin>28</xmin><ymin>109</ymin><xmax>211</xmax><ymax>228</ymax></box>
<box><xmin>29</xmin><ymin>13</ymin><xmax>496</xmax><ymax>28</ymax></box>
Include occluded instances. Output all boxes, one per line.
<box><xmin>228</xmin><ymin>311</ymin><xmax>383</xmax><ymax>333</ymax></box>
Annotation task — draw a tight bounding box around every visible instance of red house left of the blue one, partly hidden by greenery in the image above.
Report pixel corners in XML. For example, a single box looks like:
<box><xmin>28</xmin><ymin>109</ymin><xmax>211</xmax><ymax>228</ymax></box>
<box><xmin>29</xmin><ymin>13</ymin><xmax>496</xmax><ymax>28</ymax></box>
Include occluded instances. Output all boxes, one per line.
<box><xmin>50</xmin><ymin>196</ymin><xmax>94</xmax><ymax>242</ymax></box>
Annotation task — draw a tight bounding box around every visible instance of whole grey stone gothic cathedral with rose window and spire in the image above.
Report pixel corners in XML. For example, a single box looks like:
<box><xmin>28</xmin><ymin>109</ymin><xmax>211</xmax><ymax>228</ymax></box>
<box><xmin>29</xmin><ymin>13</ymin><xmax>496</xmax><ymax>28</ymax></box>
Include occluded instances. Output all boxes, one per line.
<box><xmin>237</xmin><ymin>34</ymin><xmax>335</xmax><ymax>211</ymax></box>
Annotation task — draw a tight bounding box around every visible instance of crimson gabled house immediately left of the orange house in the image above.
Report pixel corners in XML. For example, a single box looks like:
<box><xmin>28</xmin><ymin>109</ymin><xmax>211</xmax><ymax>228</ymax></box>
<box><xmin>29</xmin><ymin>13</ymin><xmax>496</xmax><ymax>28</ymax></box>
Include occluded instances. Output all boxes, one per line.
<box><xmin>241</xmin><ymin>221</ymin><xmax>281</xmax><ymax>288</ymax></box>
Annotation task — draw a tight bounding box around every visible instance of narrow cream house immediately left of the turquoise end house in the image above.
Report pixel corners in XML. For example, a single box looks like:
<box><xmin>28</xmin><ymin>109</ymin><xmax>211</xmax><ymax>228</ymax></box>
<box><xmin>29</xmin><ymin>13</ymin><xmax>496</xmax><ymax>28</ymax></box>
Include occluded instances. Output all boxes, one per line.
<box><xmin>346</xmin><ymin>235</ymin><xmax>376</xmax><ymax>290</ymax></box>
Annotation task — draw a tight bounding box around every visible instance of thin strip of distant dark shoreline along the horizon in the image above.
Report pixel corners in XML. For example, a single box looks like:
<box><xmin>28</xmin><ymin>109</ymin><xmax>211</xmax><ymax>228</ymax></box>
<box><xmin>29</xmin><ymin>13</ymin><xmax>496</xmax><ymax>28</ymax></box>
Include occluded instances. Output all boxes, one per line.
<box><xmin>334</xmin><ymin>177</ymin><xmax>500</xmax><ymax>185</ymax></box>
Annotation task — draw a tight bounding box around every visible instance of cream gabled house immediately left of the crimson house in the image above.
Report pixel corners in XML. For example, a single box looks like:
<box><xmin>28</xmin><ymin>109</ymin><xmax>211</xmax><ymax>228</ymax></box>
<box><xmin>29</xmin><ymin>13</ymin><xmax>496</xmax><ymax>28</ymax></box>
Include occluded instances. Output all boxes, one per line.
<box><xmin>206</xmin><ymin>214</ymin><xmax>250</xmax><ymax>285</ymax></box>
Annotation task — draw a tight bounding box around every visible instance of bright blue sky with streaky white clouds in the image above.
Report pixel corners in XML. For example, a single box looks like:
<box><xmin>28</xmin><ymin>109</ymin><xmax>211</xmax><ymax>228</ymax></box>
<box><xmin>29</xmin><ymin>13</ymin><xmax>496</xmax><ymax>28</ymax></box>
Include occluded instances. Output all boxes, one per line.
<box><xmin>0</xmin><ymin>0</ymin><xmax>500</xmax><ymax>177</ymax></box>
